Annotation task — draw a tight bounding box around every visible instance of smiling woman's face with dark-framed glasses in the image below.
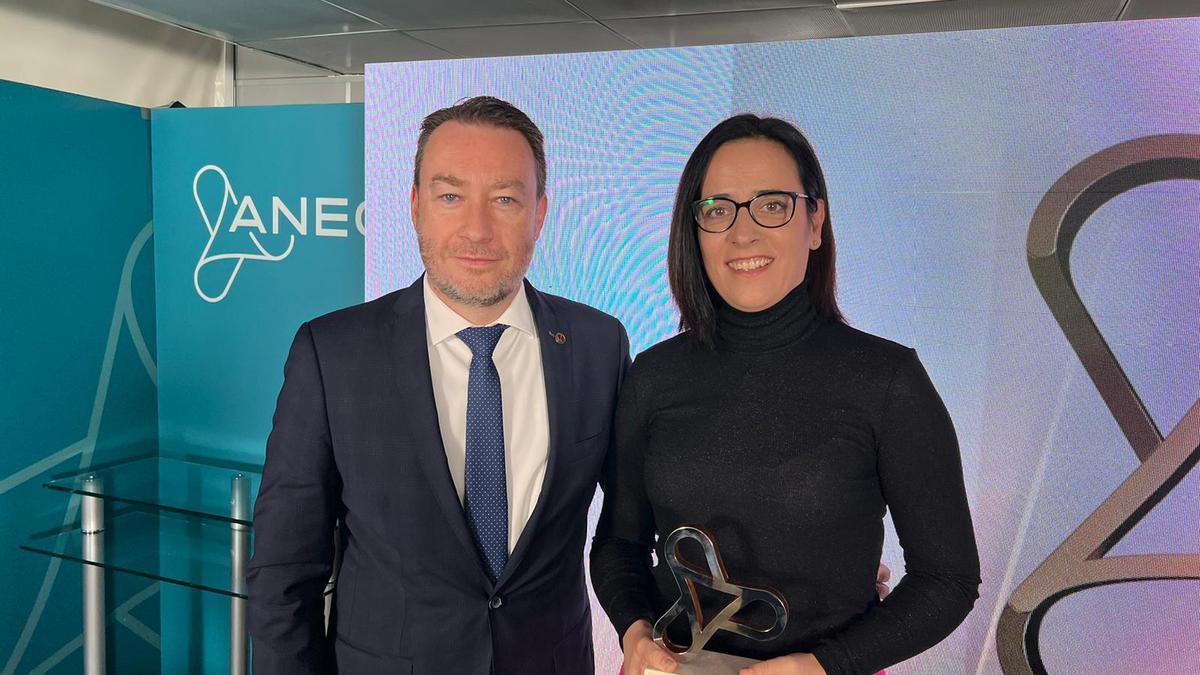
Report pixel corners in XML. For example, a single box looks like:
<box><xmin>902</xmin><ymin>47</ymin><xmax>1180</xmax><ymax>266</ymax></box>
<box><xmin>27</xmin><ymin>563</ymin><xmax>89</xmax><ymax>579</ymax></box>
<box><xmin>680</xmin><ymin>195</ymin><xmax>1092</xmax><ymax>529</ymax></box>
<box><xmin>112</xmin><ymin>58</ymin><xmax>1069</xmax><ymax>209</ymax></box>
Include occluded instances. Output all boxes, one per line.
<box><xmin>696</xmin><ymin>138</ymin><xmax>826</xmax><ymax>312</ymax></box>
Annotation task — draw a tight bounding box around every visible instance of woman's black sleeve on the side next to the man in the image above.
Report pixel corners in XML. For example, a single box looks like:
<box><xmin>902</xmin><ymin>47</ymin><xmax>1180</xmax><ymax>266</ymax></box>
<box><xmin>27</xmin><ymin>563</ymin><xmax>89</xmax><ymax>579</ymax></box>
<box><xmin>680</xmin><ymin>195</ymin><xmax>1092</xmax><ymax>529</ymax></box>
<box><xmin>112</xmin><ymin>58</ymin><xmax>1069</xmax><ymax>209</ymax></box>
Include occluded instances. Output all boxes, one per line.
<box><xmin>590</xmin><ymin>363</ymin><xmax>654</xmax><ymax>643</ymax></box>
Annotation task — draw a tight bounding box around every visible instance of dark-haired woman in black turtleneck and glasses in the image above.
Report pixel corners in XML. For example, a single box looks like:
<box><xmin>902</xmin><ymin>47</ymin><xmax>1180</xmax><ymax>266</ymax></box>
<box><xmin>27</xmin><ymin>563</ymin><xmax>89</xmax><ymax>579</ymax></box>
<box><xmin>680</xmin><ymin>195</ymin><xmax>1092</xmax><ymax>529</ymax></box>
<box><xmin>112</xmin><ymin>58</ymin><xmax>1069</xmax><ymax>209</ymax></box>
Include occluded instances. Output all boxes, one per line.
<box><xmin>592</xmin><ymin>115</ymin><xmax>979</xmax><ymax>675</ymax></box>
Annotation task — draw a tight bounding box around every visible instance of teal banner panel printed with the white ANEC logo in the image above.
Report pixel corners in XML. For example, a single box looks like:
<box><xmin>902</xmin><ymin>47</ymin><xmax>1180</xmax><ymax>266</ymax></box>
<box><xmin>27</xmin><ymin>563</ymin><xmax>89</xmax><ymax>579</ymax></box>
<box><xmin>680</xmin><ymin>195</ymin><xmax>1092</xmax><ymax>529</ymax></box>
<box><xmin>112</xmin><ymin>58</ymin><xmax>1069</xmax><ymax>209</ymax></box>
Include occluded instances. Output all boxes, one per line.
<box><xmin>151</xmin><ymin>104</ymin><xmax>365</xmax><ymax>673</ymax></box>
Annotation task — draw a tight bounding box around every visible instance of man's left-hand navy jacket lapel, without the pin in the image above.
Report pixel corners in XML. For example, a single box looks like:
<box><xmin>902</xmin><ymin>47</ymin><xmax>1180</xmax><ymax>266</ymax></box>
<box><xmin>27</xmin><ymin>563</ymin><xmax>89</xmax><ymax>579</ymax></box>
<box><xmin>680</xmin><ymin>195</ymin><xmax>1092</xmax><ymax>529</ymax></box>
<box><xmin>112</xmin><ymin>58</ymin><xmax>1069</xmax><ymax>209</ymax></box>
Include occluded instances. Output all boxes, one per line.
<box><xmin>390</xmin><ymin>277</ymin><xmax>491</xmax><ymax>585</ymax></box>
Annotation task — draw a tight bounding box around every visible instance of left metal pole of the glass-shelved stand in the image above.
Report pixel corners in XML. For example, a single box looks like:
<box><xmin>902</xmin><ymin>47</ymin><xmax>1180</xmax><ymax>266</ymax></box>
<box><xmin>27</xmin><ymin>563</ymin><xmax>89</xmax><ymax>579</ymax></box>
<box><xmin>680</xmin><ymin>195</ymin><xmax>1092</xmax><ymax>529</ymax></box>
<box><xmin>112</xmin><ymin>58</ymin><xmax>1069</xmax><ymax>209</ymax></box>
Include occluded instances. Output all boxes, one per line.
<box><xmin>80</xmin><ymin>476</ymin><xmax>107</xmax><ymax>675</ymax></box>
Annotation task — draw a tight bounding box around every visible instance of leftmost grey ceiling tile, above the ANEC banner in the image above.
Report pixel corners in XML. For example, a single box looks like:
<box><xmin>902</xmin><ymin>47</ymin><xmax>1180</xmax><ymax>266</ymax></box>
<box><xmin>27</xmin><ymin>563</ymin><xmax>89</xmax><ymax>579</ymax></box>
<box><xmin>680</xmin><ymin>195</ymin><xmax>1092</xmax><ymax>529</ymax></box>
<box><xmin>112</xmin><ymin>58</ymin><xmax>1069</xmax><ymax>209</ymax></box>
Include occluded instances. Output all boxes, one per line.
<box><xmin>93</xmin><ymin>0</ymin><xmax>379</xmax><ymax>42</ymax></box>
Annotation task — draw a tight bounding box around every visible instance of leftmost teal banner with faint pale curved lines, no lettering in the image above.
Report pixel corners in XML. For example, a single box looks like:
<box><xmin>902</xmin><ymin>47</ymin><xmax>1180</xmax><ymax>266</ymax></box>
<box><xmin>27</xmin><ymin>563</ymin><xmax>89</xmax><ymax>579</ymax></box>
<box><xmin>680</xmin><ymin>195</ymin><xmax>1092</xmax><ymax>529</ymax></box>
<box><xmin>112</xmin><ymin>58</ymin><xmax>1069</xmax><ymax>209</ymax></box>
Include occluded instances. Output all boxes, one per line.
<box><xmin>0</xmin><ymin>80</ymin><xmax>160</xmax><ymax>674</ymax></box>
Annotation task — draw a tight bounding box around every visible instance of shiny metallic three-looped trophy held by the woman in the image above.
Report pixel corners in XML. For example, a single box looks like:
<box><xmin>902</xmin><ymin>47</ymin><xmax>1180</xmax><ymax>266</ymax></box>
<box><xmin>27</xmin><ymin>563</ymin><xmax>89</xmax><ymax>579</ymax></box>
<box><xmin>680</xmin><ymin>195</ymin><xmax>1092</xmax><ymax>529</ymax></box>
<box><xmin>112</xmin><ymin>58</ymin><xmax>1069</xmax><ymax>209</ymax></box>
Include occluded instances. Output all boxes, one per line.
<box><xmin>644</xmin><ymin>526</ymin><xmax>787</xmax><ymax>675</ymax></box>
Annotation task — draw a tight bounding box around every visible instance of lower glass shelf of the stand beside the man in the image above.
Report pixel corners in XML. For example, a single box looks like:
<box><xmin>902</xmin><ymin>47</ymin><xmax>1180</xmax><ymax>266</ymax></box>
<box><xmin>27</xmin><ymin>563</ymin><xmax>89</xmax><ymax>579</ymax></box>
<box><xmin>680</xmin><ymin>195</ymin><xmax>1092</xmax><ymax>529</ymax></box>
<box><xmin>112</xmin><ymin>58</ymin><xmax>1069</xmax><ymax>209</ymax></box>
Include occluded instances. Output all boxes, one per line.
<box><xmin>20</xmin><ymin>507</ymin><xmax>250</xmax><ymax>598</ymax></box>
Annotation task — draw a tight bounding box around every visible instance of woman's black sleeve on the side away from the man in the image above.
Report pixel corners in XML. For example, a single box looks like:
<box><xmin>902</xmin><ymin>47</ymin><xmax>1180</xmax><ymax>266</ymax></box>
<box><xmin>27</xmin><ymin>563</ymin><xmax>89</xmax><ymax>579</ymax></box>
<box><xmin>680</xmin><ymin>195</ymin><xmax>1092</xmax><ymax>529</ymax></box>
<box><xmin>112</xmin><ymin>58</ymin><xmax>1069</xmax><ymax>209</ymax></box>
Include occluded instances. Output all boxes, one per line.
<box><xmin>814</xmin><ymin>350</ymin><xmax>980</xmax><ymax>675</ymax></box>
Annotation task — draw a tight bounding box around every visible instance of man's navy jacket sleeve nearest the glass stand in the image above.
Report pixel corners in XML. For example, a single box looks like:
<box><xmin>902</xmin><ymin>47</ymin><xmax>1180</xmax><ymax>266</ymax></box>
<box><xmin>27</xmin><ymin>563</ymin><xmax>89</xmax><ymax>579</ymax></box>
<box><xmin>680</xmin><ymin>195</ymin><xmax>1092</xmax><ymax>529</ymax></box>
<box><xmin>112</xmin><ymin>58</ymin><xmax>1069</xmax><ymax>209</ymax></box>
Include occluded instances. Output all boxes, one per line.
<box><xmin>246</xmin><ymin>324</ymin><xmax>341</xmax><ymax>675</ymax></box>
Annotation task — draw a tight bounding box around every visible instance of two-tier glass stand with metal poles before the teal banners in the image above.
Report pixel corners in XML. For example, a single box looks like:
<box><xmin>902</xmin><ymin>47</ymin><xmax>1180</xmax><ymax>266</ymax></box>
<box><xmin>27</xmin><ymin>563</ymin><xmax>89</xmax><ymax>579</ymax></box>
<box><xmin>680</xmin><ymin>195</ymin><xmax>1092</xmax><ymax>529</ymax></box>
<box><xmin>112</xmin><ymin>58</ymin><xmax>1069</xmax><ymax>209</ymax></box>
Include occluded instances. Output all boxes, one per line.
<box><xmin>20</xmin><ymin>458</ymin><xmax>334</xmax><ymax>673</ymax></box>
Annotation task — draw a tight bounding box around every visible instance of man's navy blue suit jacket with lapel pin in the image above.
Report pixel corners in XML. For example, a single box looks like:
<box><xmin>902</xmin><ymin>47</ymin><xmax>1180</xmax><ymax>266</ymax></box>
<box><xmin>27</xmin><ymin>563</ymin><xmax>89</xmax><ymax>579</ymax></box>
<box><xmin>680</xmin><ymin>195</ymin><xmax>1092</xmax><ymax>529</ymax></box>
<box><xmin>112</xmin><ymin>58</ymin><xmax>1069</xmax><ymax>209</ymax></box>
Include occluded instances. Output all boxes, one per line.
<box><xmin>247</xmin><ymin>280</ymin><xmax>629</xmax><ymax>675</ymax></box>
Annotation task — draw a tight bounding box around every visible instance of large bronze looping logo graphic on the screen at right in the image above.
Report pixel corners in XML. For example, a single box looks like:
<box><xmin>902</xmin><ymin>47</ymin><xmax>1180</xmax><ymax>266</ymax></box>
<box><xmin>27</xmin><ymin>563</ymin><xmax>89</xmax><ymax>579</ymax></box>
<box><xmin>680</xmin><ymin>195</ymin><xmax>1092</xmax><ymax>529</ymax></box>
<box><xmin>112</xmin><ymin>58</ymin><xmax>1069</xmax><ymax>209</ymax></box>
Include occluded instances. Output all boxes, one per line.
<box><xmin>996</xmin><ymin>133</ymin><xmax>1200</xmax><ymax>675</ymax></box>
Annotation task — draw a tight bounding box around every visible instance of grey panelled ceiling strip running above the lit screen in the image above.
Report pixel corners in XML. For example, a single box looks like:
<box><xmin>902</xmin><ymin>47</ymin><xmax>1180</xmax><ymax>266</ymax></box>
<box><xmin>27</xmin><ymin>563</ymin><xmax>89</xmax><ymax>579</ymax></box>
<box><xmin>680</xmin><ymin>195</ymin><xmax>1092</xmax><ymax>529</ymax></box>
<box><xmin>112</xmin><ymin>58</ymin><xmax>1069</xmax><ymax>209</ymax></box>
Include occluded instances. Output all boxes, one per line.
<box><xmin>96</xmin><ymin>0</ymin><xmax>1200</xmax><ymax>85</ymax></box>
